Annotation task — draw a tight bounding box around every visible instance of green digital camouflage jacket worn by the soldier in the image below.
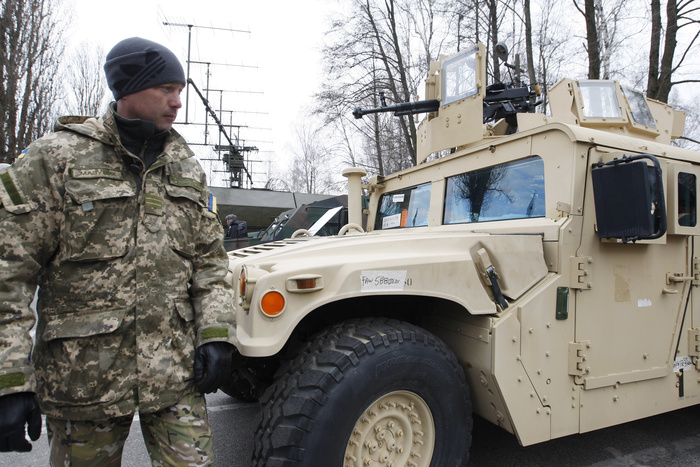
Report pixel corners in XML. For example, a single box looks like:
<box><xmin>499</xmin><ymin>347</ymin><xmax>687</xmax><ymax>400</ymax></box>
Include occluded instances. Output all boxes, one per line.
<box><xmin>0</xmin><ymin>109</ymin><xmax>235</xmax><ymax>420</ymax></box>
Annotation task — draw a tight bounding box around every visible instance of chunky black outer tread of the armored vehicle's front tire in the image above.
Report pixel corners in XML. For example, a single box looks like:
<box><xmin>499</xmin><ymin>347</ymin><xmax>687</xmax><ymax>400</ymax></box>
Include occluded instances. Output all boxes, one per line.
<box><xmin>253</xmin><ymin>318</ymin><xmax>471</xmax><ymax>467</ymax></box>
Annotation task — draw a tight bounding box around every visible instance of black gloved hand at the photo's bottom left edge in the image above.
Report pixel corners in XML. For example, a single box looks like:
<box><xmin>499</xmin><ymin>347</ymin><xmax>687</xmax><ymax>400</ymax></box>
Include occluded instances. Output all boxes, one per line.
<box><xmin>0</xmin><ymin>392</ymin><xmax>41</xmax><ymax>452</ymax></box>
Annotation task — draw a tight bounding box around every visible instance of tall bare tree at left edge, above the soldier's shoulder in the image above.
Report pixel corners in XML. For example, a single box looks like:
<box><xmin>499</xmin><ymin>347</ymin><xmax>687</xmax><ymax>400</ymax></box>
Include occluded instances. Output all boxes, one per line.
<box><xmin>0</xmin><ymin>0</ymin><xmax>63</xmax><ymax>162</ymax></box>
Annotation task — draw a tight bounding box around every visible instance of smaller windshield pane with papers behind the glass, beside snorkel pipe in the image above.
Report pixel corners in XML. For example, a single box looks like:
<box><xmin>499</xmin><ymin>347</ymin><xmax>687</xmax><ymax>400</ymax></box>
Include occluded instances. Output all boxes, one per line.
<box><xmin>374</xmin><ymin>183</ymin><xmax>431</xmax><ymax>230</ymax></box>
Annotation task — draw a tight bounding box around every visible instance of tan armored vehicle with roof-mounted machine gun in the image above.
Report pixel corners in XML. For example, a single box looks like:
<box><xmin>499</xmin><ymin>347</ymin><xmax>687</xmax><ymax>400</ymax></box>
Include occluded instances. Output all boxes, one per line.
<box><xmin>227</xmin><ymin>45</ymin><xmax>700</xmax><ymax>467</ymax></box>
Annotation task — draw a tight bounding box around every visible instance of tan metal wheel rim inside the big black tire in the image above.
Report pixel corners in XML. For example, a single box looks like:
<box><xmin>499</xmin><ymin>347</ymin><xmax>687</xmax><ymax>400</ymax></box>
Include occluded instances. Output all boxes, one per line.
<box><xmin>343</xmin><ymin>391</ymin><xmax>435</xmax><ymax>467</ymax></box>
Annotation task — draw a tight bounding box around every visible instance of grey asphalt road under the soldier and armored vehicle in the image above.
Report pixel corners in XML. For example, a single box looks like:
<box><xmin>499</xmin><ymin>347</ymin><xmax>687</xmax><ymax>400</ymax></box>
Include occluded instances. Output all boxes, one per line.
<box><xmin>0</xmin><ymin>392</ymin><xmax>700</xmax><ymax>467</ymax></box>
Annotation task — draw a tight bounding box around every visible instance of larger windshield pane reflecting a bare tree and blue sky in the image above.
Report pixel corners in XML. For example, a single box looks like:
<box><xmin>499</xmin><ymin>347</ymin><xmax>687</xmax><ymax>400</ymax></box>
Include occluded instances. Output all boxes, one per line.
<box><xmin>443</xmin><ymin>156</ymin><xmax>545</xmax><ymax>224</ymax></box>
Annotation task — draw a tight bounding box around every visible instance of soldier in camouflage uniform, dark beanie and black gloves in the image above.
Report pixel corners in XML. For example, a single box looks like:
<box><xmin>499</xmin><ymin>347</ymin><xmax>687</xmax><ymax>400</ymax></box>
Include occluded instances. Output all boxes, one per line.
<box><xmin>0</xmin><ymin>37</ymin><xmax>235</xmax><ymax>465</ymax></box>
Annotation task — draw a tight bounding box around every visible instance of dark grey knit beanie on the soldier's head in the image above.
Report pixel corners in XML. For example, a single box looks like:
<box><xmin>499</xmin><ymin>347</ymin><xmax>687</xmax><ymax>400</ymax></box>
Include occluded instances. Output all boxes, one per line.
<box><xmin>105</xmin><ymin>37</ymin><xmax>186</xmax><ymax>100</ymax></box>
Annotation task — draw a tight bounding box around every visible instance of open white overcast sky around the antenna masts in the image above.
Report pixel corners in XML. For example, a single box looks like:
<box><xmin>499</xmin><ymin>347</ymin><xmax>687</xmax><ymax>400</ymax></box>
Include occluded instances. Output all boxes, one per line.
<box><xmin>70</xmin><ymin>0</ymin><xmax>335</xmax><ymax>188</ymax></box>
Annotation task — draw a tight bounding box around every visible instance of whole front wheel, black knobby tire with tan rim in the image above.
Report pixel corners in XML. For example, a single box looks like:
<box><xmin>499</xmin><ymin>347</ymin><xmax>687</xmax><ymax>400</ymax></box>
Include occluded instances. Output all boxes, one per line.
<box><xmin>253</xmin><ymin>318</ymin><xmax>472</xmax><ymax>467</ymax></box>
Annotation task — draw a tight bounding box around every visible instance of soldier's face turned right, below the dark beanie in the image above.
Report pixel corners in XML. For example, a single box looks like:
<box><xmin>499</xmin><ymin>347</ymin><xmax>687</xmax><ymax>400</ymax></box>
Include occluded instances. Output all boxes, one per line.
<box><xmin>117</xmin><ymin>83</ymin><xmax>184</xmax><ymax>131</ymax></box>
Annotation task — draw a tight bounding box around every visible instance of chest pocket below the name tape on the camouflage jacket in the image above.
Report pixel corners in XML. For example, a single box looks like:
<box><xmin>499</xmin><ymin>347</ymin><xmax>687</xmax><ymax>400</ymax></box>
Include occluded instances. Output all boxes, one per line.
<box><xmin>62</xmin><ymin>169</ymin><xmax>138</xmax><ymax>261</ymax></box>
